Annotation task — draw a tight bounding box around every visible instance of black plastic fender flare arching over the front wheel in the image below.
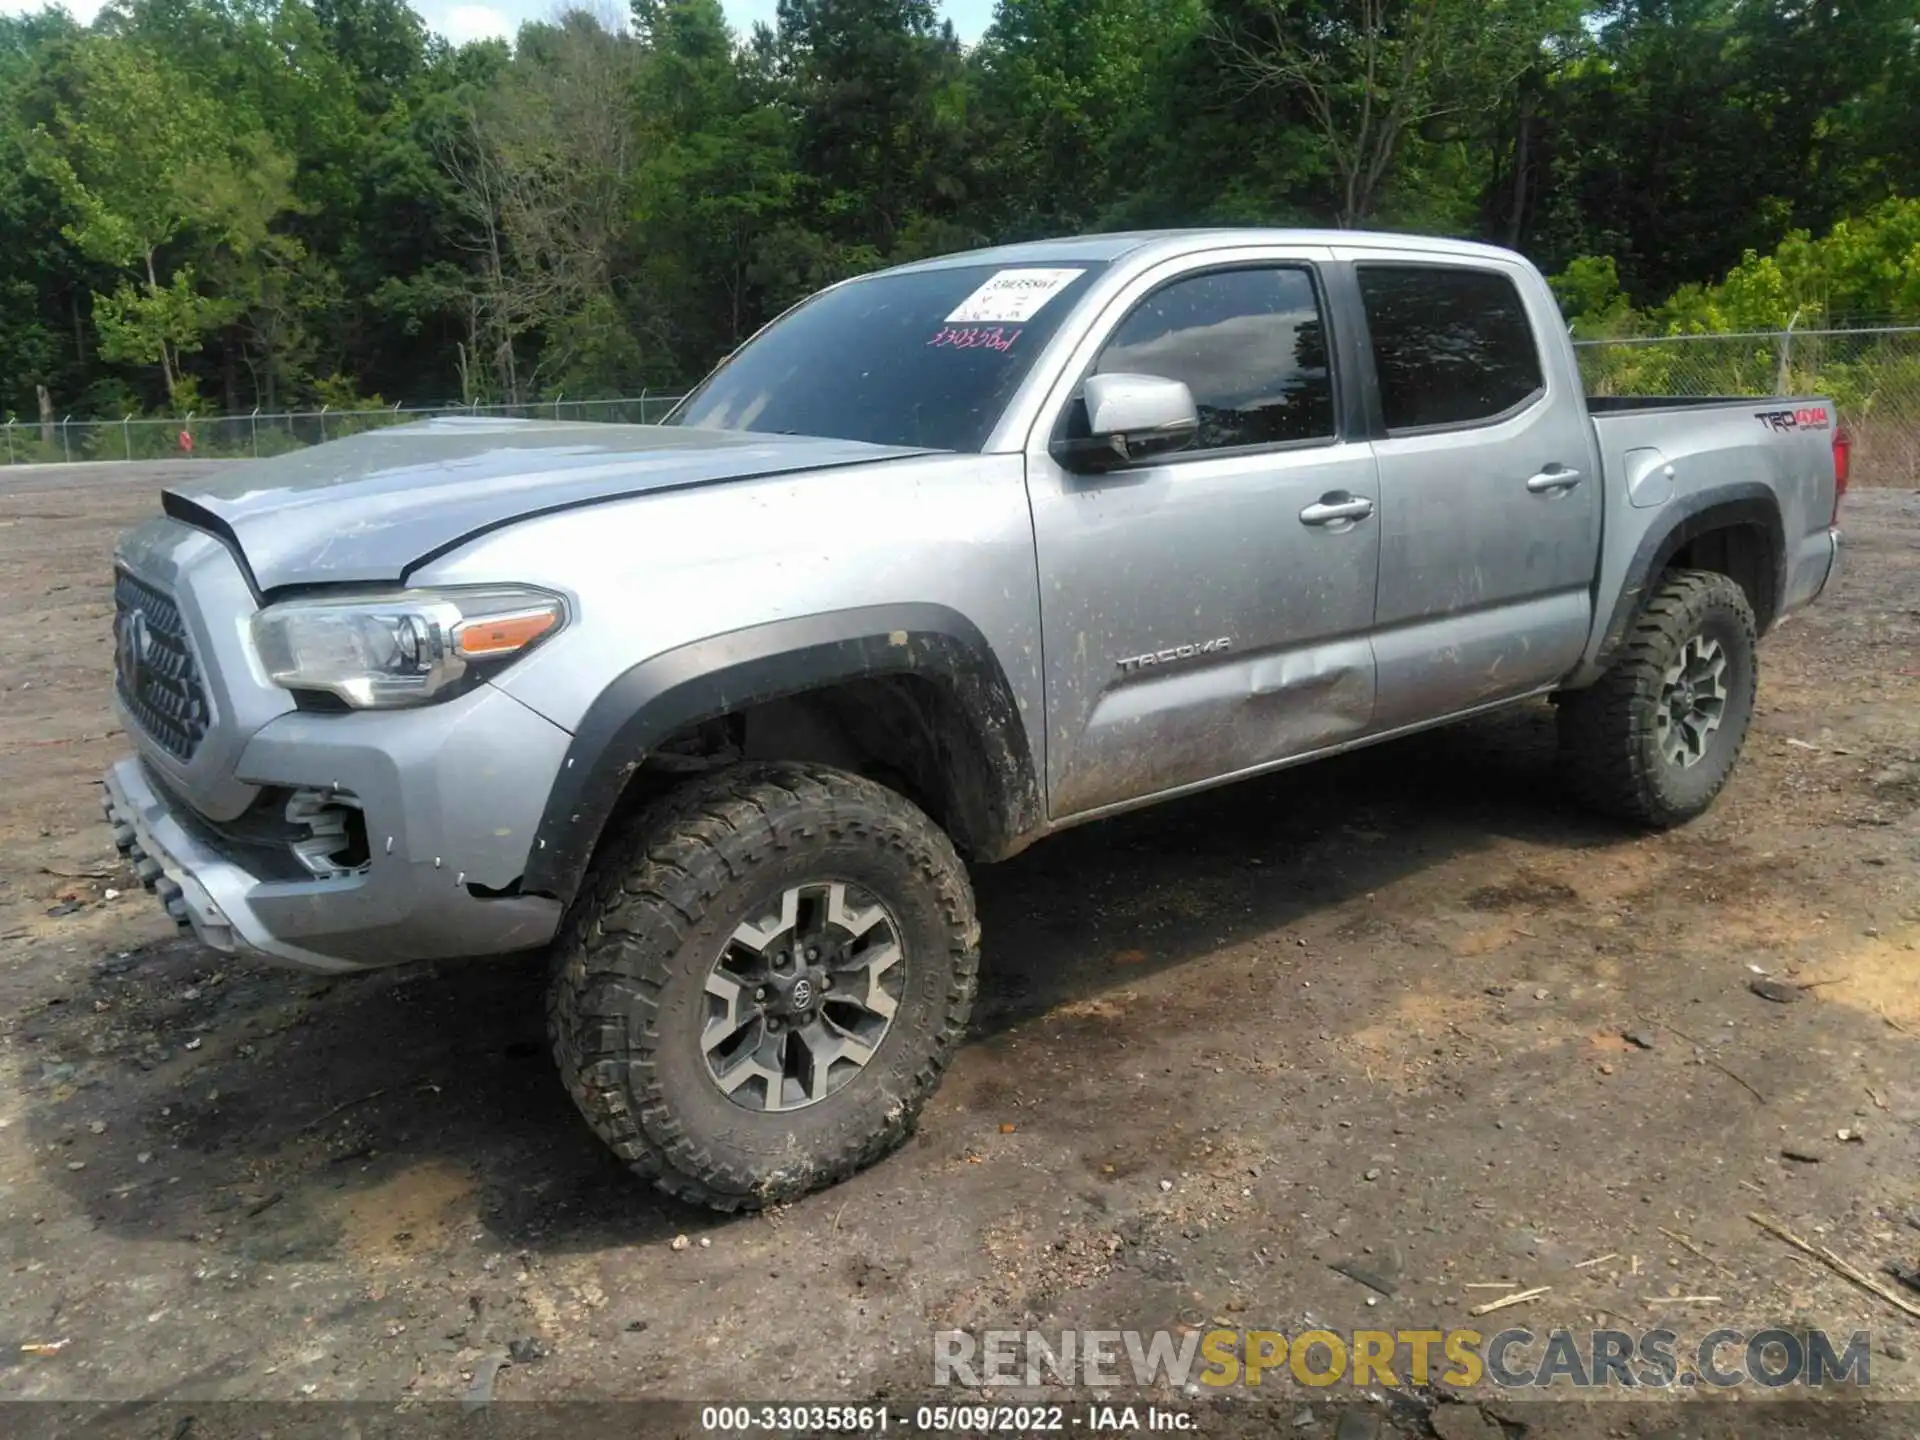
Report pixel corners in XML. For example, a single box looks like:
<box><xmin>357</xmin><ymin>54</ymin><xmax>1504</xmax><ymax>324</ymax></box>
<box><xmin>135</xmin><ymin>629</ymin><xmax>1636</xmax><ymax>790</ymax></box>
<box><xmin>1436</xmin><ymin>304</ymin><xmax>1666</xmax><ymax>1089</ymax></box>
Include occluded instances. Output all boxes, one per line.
<box><xmin>520</xmin><ymin>605</ymin><xmax>1044</xmax><ymax>904</ymax></box>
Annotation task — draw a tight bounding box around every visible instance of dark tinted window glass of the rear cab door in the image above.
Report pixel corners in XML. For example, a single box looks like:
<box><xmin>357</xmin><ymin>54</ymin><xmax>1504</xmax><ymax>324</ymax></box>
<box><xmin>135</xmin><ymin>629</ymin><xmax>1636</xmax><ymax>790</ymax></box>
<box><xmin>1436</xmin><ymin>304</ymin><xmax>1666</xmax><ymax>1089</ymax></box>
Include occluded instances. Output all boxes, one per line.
<box><xmin>1359</xmin><ymin>265</ymin><xmax>1546</xmax><ymax>430</ymax></box>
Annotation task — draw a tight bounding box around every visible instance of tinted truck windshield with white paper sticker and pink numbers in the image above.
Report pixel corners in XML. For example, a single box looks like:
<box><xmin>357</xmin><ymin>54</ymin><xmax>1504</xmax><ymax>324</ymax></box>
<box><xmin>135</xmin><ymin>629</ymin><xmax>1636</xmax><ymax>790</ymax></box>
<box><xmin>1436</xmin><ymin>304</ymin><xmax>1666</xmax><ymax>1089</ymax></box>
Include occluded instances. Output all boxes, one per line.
<box><xmin>668</xmin><ymin>261</ymin><xmax>1102</xmax><ymax>451</ymax></box>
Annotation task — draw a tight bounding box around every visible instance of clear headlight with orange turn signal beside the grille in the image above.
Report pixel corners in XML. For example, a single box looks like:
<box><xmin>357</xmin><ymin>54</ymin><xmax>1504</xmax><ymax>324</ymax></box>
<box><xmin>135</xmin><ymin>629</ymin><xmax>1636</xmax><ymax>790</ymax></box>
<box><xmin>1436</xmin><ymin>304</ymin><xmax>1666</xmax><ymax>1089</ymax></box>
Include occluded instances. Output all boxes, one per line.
<box><xmin>253</xmin><ymin>586</ymin><xmax>566</xmax><ymax>710</ymax></box>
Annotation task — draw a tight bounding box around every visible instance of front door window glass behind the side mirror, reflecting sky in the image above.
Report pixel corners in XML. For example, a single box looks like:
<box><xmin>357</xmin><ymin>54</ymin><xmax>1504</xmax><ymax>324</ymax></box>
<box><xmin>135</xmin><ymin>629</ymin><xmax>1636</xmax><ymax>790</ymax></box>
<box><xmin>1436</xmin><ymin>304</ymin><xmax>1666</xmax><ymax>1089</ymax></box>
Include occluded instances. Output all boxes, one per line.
<box><xmin>1094</xmin><ymin>265</ymin><xmax>1334</xmax><ymax>453</ymax></box>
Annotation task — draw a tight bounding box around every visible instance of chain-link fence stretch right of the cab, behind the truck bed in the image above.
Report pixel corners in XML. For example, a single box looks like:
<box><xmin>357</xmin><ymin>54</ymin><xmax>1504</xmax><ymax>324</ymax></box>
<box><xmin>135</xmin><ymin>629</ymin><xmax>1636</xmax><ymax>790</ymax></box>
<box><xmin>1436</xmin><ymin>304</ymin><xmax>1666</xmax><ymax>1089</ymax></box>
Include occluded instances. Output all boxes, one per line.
<box><xmin>1574</xmin><ymin>326</ymin><xmax>1920</xmax><ymax>488</ymax></box>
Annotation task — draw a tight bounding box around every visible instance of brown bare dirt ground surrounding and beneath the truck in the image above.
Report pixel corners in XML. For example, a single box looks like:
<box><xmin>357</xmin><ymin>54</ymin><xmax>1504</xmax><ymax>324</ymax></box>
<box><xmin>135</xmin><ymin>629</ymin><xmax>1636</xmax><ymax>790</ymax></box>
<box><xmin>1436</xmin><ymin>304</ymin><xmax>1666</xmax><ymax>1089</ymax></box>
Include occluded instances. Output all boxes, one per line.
<box><xmin>0</xmin><ymin>467</ymin><xmax>1920</xmax><ymax>1440</ymax></box>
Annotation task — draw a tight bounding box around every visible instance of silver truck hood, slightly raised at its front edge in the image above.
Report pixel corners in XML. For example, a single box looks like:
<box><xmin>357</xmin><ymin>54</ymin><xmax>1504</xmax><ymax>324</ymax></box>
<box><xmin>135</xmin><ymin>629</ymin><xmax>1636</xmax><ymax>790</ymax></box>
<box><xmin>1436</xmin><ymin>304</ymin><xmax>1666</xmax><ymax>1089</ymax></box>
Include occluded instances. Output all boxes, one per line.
<box><xmin>161</xmin><ymin>417</ymin><xmax>927</xmax><ymax>593</ymax></box>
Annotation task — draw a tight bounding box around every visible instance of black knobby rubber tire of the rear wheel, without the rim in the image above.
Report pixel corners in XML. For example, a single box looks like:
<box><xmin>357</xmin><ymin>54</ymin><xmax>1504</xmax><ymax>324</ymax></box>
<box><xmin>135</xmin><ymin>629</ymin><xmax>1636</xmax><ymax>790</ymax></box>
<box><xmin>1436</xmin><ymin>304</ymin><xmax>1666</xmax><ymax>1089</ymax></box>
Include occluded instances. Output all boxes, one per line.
<box><xmin>1557</xmin><ymin>570</ymin><xmax>1759</xmax><ymax>829</ymax></box>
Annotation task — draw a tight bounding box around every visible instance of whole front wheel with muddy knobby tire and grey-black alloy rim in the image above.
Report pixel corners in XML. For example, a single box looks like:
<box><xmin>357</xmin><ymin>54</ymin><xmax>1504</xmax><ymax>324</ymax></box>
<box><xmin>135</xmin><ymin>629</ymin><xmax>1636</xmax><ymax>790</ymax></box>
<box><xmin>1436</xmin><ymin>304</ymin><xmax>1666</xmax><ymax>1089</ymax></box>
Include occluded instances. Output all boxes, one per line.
<box><xmin>547</xmin><ymin>764</ymin><xmax>979</xmax><ymax>1210</ymax></box>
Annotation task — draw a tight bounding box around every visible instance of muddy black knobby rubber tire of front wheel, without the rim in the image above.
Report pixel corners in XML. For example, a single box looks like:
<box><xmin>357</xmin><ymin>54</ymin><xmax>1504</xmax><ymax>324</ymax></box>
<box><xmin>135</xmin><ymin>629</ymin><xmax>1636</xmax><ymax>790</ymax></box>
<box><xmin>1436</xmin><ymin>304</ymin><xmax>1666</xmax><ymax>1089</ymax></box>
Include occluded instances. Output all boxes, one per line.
<box><xmin>547</xmin><ymin>762</ymin><xmax>979</xmax><ymax>1212</ymax></box>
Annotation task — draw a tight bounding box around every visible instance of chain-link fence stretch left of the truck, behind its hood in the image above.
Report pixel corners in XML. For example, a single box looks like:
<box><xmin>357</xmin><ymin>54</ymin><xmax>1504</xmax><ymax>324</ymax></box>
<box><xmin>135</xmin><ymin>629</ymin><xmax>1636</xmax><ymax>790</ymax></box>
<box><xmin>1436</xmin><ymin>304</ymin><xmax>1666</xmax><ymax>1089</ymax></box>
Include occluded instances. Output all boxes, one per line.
<box><xmin>0</xmin><ymin>394</ymin><xmax>680</xmax><ymax>465</ymax></box>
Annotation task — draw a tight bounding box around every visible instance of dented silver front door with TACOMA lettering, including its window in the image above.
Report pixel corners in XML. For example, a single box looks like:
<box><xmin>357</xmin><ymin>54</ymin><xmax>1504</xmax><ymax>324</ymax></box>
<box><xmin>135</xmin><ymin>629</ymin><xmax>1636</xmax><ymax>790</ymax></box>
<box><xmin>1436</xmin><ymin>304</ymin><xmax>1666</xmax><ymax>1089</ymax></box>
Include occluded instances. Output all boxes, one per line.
<box><xmin>1027</xmin><ymin>252</ymin><xmax>1380</xmax><ymax>822</ymax></box>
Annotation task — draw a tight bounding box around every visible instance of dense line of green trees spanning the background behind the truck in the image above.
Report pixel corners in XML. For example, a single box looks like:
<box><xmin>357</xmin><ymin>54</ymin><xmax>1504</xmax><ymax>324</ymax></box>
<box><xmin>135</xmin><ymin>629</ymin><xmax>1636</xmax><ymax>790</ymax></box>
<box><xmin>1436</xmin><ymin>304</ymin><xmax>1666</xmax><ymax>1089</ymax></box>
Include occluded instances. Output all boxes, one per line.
<box><xmin>0</xmin><ymin>0</ymin><xmax>1920</xmax><ymax>415</ymax></box>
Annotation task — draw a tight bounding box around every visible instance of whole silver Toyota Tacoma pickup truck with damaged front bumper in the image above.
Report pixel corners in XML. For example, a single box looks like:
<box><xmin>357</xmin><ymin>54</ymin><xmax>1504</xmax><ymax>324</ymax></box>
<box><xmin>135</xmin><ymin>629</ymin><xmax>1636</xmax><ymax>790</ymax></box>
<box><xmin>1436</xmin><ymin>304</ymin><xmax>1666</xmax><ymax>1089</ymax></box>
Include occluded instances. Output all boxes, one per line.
<box><xmin>106</xmin><ymin>230</ymin><xmax>1847</xmax><ymax>1210</ymax></box>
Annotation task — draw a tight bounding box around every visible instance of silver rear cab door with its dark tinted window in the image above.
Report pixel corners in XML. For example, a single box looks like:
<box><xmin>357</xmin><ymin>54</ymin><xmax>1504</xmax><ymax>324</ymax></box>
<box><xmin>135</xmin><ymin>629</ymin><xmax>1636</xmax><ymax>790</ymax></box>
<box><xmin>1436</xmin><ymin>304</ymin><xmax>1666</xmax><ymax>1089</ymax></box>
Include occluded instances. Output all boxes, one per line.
<box><xmin>1340</xmin><ymin>248</ymin><xmax>1601</xmax><ymax>732</ymax></box>
